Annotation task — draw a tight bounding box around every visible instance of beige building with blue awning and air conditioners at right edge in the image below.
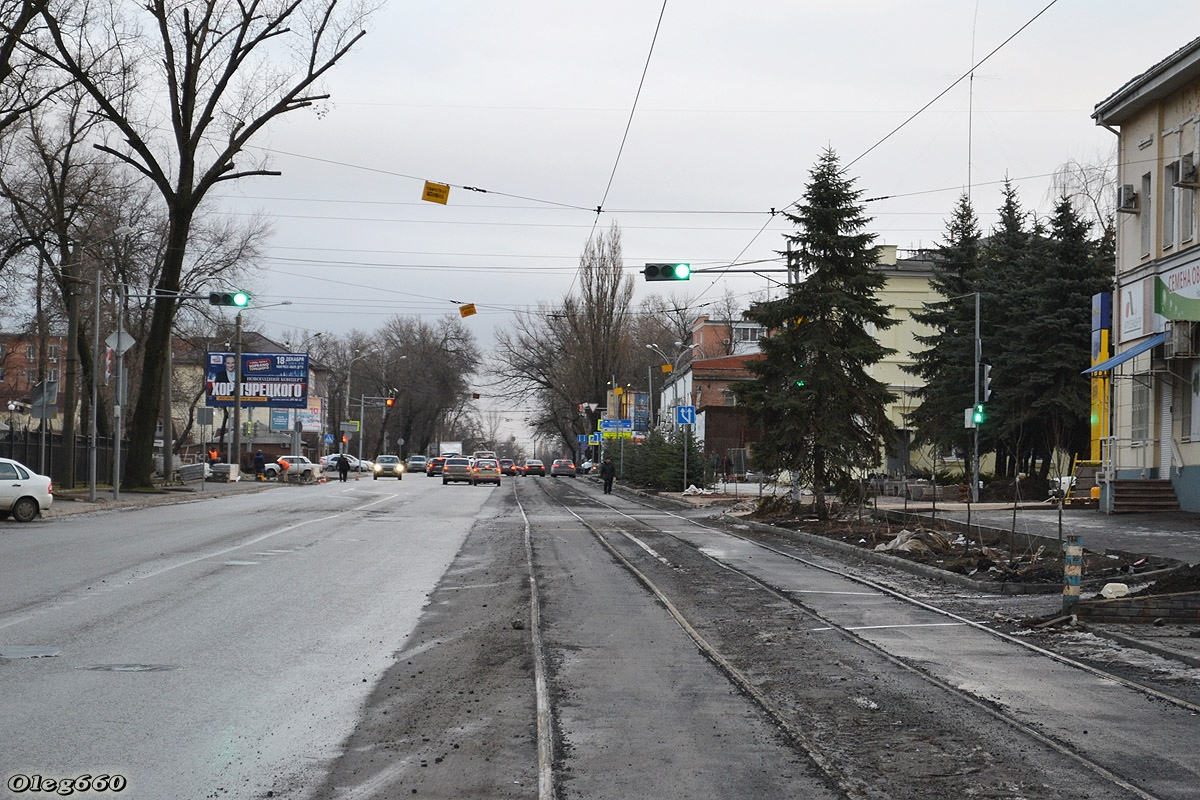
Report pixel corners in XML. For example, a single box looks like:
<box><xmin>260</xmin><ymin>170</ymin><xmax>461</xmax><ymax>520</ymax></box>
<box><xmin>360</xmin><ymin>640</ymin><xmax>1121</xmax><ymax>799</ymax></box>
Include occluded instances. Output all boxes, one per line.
<box><xmin>1092</xmin><ymin>40</ymin><xmax>1200</xmax><ymax>511</ymax></box>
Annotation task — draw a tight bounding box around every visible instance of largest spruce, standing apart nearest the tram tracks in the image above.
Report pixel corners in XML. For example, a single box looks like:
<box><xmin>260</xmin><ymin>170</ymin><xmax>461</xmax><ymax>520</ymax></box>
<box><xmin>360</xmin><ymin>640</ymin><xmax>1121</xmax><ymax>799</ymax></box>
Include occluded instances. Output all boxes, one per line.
<box><xmin>736</xmin><ymin>150</ymin><xmax>894</xmax><ymax>519</ymax></box>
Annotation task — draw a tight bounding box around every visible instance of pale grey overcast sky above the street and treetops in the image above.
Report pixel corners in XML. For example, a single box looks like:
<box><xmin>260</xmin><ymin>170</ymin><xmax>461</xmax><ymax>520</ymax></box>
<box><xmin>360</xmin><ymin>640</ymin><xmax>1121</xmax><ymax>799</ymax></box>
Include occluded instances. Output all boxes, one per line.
<box><xmin>216</xmin><ymin>0</ymin><xmax>1196</xmax><ymax>349</ymax></box>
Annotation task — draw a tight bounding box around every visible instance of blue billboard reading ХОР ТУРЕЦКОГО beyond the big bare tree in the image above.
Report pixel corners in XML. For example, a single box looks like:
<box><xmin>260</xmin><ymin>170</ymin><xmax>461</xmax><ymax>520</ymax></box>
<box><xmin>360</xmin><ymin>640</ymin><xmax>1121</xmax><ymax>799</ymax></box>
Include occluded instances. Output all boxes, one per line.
<box><xmin>204</xmin><ymin>350</ymin><xmax>308</xmax><ymax>409</ymax></box>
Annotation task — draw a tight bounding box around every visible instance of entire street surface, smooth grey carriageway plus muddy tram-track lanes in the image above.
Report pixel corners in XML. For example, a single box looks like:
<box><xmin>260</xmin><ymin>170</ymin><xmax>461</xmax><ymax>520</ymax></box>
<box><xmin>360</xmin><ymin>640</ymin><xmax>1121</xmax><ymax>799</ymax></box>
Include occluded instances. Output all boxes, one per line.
<box><xmin>0</xmin><ymin>476</ymin><xmax>1200</xmax><ymax>800</ymax></box>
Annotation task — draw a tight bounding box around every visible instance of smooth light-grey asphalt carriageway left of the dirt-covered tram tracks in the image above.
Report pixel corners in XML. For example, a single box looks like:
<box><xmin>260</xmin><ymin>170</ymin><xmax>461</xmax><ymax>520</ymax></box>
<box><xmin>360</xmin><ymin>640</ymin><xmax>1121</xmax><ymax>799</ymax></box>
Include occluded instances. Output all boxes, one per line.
<box><xmin>0</xmin><ymin>481</ymin><xmax>487</xmax><ymax>800</ymax></box>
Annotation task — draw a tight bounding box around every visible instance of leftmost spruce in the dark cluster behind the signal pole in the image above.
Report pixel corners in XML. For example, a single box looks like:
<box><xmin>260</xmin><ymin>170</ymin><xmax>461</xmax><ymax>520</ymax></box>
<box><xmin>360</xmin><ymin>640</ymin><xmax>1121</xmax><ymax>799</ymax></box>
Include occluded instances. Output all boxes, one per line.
<box><xmin>907</xmin><ymin>194</ymin><xmax>982</xmax><ymax>465</ymax></box>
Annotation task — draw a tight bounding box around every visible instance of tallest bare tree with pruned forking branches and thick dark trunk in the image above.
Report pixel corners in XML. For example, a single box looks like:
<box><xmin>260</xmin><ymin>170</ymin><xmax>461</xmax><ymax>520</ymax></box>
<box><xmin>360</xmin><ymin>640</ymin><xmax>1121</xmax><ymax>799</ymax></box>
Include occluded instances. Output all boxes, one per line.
<box><xmin>36</xmin><ymin>0</ymin><xmax>367</xmax><ymax>488</ymax></box>
